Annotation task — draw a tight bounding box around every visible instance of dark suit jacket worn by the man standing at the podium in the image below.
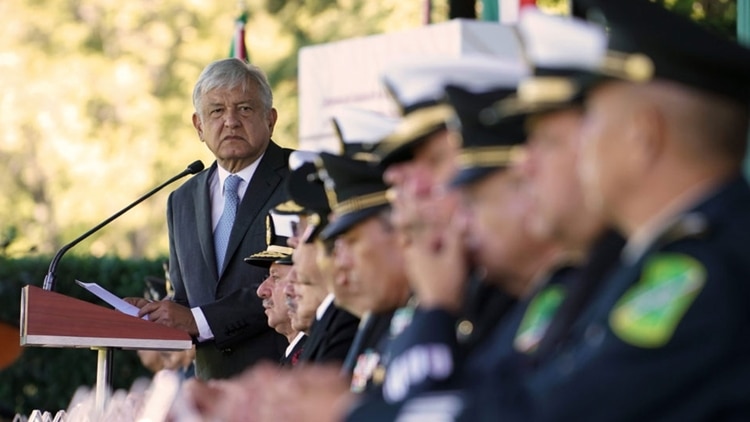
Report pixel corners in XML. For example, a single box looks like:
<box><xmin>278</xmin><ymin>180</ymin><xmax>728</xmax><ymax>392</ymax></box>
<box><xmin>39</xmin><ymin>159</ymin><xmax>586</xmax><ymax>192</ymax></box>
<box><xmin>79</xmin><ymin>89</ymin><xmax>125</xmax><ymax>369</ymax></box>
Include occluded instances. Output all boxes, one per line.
<box><xmin>167</xmin><ymin>142</ymin><xmax>291</xmax><ymax>379</ymax></box>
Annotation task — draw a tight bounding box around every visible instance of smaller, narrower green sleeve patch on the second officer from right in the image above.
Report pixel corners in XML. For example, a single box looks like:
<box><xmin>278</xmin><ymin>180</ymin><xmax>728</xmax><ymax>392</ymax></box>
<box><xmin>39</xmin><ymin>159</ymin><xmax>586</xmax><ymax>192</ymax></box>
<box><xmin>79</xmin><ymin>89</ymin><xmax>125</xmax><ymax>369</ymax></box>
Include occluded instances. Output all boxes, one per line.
<box><xmin>513</xmin><ymin>284</ymin><xmax>565</xmax><ymax>354</ymax></box>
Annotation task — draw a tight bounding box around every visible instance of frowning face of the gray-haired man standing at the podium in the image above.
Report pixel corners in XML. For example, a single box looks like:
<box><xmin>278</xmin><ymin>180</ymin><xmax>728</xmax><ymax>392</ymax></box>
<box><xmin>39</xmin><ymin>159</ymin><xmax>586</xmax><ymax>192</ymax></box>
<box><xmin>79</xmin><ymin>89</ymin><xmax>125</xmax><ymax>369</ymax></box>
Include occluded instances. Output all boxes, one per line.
<box><xmin>193</xmin><ymin>83</ymin><xmax>277</xmax><ymax>171</ymax></box>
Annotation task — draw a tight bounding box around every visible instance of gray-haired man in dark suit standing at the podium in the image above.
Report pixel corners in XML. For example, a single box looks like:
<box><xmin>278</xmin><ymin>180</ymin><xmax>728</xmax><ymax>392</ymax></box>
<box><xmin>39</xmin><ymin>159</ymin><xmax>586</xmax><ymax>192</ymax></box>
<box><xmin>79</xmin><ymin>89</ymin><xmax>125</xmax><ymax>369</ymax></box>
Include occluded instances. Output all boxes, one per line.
<box><xmin>132</xmin><ymin>59</ymin><xmax>290</xmax><ymax>379</ymax></box>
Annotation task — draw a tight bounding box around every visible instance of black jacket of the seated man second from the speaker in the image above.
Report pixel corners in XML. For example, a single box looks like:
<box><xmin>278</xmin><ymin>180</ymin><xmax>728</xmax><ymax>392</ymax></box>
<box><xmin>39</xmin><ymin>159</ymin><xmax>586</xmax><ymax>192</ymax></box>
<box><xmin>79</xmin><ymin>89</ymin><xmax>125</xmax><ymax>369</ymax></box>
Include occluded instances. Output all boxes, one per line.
<box><xmin>300</xmin><ymin>303</ymin><xmax>359</xmax><ymax>363</ymax></box>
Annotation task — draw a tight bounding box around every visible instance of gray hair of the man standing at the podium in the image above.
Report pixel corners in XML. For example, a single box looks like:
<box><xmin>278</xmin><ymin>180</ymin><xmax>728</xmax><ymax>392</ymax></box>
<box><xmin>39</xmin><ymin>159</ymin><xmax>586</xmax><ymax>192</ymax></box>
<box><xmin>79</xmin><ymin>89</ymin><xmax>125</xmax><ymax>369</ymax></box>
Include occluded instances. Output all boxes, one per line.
<box><xmin>193</xmin><ymin>58</ymin><xmax>273</xmax><ymax>113</ymax></box>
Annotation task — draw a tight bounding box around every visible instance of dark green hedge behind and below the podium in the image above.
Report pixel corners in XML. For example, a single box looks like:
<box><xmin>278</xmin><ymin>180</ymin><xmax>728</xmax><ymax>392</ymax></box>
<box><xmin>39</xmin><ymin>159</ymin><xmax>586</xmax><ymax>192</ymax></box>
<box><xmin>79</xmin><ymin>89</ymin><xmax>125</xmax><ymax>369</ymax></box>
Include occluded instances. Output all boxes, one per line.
<box><xmin>0</xmin><ymin>255</ymin><xmax>164</xmax><ymax>420</ymax></box>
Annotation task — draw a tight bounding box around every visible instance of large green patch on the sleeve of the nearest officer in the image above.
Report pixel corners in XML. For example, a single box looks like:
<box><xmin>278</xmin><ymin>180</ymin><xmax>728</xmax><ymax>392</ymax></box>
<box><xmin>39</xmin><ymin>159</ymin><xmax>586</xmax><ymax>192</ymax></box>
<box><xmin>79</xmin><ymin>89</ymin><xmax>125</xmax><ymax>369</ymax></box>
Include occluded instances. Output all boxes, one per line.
<box><xmin>609</xmin><ymin>253</ymin><xmax>706</xmax><ymax>348</ymax></box>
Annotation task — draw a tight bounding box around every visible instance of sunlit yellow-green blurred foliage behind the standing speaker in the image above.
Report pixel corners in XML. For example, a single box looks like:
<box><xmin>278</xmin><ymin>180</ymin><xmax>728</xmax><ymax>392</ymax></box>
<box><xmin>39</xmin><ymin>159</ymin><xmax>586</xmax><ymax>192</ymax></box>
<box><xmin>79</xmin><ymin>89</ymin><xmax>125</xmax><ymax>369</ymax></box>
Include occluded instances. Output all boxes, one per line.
<box><xmin>0</xmin><ymin>0</ymin><xmax>440</xmax><ymax>257</ymax></box>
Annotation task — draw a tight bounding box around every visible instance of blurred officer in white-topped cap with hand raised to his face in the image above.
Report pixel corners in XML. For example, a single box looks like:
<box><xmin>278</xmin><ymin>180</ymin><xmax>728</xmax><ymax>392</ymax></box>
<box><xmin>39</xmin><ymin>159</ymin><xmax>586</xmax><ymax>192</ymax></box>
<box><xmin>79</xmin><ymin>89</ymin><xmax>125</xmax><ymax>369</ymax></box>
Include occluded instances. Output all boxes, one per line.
<box><xmin>368</xmin><ymin>56</ymin><xmax>546</xmax><ymax>401</ymax></box>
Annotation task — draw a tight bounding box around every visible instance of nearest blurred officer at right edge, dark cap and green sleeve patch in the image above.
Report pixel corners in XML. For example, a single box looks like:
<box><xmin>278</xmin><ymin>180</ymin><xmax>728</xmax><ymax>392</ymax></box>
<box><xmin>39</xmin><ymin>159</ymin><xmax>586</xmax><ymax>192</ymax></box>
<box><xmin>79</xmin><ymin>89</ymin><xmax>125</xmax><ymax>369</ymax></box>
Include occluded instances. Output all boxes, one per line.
<box><xmin>516</xmin><ymin>0</ymin><xmax>750</xmax><ymax>421</ymax></box>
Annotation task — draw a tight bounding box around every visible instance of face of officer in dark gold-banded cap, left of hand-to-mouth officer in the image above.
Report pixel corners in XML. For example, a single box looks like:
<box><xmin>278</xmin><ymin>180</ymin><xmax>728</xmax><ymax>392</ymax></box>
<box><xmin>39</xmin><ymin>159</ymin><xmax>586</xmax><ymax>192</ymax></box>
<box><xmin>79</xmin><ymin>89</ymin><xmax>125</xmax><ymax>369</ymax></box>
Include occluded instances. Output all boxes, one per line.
<box><xmin>334</xmin><ymin>216</ymin><xmax>409</xmax><ymax>315</ymax></box>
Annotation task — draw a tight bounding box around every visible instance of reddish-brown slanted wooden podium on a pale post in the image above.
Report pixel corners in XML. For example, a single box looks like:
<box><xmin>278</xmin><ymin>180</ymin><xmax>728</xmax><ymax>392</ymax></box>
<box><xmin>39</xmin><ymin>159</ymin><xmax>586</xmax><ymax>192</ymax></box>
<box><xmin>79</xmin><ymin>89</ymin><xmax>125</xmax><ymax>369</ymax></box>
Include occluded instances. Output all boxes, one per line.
<box><xmin>20</xmin><ymin>285</ymin><xmax>193</xmax><ymax>411</ymax></box>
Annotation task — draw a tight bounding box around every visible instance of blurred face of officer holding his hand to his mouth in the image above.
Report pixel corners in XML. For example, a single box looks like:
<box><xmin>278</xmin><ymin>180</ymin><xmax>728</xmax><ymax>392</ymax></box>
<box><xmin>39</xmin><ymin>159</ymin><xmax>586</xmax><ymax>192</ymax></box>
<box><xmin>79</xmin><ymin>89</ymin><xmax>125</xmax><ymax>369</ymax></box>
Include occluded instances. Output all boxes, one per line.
<box><xmin>383</xmin><ymin>130</ymin><xmax>459</xmax><ymax>241</ymax></box>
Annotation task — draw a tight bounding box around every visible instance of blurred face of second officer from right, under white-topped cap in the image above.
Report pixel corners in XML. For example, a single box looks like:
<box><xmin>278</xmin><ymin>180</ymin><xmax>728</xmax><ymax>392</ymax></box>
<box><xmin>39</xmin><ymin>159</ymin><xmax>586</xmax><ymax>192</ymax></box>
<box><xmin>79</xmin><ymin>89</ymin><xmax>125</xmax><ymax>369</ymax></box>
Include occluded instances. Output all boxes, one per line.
<box><xmin>520</xmin><ymin>109</ymin><xmax>589</xmax><ymax>240</ymax></box>
